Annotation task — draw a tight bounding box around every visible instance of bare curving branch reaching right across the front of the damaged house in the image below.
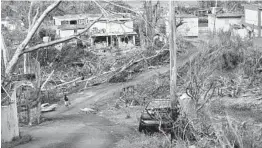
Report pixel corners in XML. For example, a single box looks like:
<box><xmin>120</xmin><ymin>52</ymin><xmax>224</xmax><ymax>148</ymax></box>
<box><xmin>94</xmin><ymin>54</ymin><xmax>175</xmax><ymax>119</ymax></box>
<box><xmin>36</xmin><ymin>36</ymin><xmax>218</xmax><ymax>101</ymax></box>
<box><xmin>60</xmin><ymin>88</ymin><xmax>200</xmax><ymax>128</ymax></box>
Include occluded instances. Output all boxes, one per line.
<box><xmin>20</xmin><ymin>15</ymin><xmax>103</xmax><ymax>55</ymax></box>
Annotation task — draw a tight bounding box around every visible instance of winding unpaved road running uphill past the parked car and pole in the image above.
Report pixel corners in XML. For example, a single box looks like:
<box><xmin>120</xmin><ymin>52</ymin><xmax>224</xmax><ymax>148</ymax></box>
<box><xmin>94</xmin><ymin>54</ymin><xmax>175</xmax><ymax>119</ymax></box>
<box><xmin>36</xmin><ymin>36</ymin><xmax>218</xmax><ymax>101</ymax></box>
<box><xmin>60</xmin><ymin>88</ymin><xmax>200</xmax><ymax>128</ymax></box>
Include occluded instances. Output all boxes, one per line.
<box><xmin>16</xmin><ymin>42</ymin><xmax>201</xmax><ymax>148</ymax></box>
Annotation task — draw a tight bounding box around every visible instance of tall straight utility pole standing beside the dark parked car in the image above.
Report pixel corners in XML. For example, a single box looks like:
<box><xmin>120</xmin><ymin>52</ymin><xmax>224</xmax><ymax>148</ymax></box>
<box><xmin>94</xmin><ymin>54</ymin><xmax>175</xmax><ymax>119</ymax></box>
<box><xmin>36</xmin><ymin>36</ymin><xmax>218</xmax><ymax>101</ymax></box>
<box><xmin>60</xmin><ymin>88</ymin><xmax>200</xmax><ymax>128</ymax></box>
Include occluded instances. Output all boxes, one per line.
<box><xmin>169</xmin><ymin>0</ymin><xmax>178</xmax><ymax>110</ymax></box>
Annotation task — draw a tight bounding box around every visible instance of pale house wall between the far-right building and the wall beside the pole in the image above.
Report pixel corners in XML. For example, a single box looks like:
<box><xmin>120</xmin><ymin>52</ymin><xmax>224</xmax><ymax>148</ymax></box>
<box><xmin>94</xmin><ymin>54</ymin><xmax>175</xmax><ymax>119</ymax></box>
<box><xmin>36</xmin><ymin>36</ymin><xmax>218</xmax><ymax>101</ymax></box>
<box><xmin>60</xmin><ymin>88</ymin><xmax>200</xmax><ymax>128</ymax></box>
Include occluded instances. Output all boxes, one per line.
<box><xmin>208</xmin><ymin>16</ymin><xmax>241</xmax><ymax>32</ymax></box>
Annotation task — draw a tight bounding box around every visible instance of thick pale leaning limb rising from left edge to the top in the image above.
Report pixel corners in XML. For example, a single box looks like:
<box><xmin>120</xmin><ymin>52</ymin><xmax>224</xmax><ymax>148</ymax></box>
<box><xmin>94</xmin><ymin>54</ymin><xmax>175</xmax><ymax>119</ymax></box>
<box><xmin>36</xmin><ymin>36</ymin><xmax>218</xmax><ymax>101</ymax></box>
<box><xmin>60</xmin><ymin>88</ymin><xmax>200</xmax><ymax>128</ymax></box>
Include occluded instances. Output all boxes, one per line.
<box><xmin>5</xmin><ymin>0</ymin><xmax>61</xmax><ymax>75</ymax></box>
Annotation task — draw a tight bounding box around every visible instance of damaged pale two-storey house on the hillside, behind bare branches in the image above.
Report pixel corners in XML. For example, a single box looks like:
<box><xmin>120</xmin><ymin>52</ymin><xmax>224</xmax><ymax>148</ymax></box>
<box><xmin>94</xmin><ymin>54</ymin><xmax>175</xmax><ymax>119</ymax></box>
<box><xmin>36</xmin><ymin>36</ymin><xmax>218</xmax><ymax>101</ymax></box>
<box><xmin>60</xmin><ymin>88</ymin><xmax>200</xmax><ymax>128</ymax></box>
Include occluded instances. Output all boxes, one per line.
<box><xmin>53</xmin><ymin>13</ymin><xmax>137</xmax><ymax>47</ymax></box>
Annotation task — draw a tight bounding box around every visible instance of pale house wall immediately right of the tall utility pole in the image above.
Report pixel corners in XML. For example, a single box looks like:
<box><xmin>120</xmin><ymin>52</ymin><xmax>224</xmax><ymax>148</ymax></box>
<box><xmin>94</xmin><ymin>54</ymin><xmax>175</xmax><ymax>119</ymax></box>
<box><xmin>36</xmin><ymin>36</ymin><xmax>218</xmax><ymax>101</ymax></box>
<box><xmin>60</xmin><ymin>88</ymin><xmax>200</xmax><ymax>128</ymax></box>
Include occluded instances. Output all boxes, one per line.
<box><xmin>177</xmin><ymin>17</ymin><xmax>198</xmax><ymax>36</ymax></box>
